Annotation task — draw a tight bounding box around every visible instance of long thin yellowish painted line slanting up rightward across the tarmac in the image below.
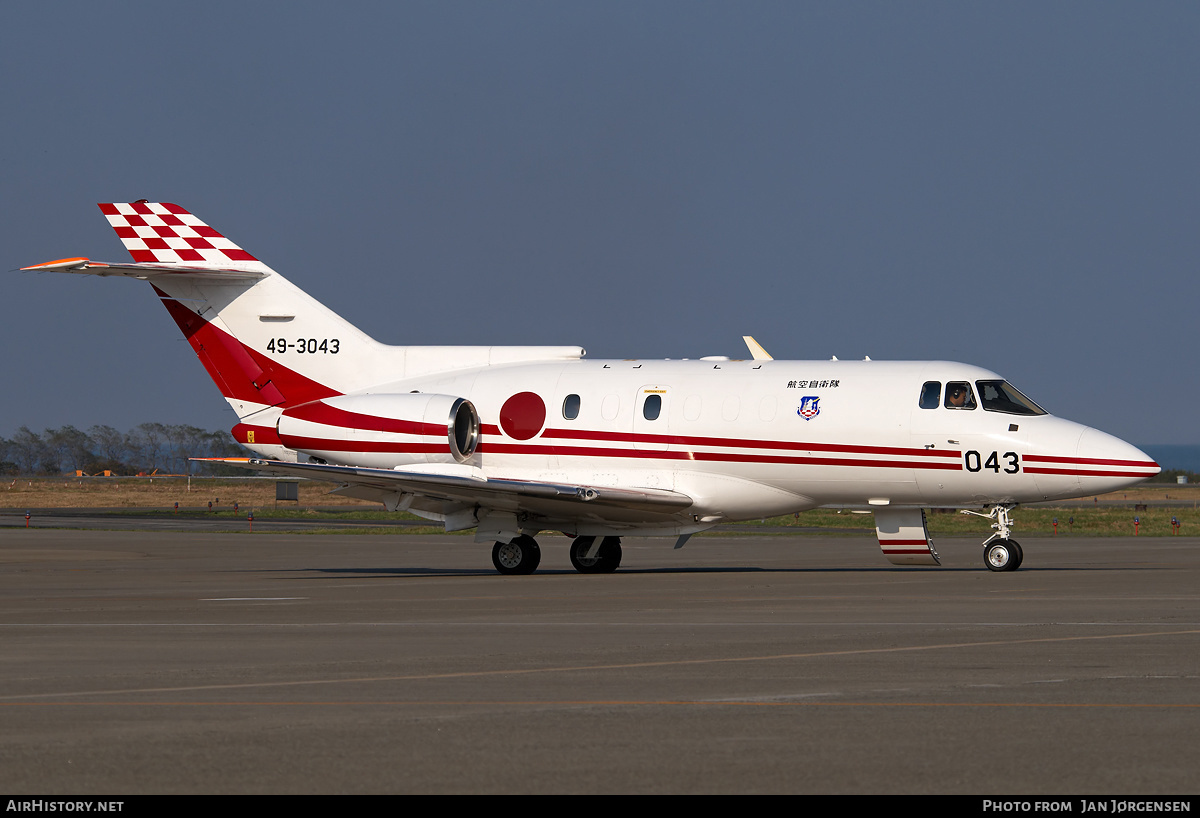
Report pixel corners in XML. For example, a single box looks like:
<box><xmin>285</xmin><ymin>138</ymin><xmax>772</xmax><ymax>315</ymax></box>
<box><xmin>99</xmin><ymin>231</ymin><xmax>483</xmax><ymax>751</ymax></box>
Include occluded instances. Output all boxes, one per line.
<box><xmin>0</xmin><ymin>630</ymin><xmax>1200</xmax><ymax>704</ymax></box>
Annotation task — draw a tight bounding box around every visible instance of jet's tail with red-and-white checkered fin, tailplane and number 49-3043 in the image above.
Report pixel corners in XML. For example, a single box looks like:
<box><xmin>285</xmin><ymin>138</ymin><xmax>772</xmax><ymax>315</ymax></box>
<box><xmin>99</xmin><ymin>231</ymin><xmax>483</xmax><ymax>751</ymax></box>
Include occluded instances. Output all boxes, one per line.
<box><xmin>23</xmin><ymin>199</ymin><xmax>583</xmax><ymax>459</ymax></box>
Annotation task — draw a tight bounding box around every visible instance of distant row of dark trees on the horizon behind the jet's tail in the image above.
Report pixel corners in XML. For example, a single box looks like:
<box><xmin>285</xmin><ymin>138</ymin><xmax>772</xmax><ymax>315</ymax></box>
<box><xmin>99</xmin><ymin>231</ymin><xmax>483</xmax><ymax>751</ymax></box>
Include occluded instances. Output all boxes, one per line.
<box><xmin>0</xmin><ymin>423</ymin><xmax>246</xmax><ymax>475</ymax></box>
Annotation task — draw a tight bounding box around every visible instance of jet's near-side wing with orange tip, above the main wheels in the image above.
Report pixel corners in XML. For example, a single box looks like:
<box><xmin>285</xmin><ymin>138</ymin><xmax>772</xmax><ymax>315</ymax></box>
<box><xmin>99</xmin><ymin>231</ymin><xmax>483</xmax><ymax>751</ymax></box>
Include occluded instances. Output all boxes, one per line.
<box><xmin>196</xmin><ymin>457</ymin><xmax>692</xmax><ymax>515</ymax></box>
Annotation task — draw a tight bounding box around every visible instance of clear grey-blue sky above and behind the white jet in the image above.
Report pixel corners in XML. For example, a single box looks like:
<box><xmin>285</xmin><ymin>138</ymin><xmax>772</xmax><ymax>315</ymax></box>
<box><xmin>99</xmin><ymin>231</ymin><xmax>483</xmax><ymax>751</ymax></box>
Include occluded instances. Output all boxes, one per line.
<box><xmin>0</xmin><ymin>1</ymin><xmax>1200</xmax><ymax>444</ymax></box>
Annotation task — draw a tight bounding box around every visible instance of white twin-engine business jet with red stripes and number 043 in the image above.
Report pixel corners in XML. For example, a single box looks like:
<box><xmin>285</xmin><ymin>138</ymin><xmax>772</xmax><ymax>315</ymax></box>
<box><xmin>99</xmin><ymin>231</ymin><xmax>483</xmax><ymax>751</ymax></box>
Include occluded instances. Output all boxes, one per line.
<box><xmin>25</xmin><ymin>200</ymin><xmax>1159</xmax><ymax>575</ymax></box>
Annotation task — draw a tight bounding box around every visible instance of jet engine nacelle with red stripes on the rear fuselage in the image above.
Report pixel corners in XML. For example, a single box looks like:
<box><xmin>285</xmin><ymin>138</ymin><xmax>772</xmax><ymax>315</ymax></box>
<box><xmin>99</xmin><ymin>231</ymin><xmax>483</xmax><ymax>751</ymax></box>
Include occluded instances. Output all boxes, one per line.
<box><xmin>276</xmin><ymin>392</ymin><xmax>479</xmax><ymax>469</ymax></box>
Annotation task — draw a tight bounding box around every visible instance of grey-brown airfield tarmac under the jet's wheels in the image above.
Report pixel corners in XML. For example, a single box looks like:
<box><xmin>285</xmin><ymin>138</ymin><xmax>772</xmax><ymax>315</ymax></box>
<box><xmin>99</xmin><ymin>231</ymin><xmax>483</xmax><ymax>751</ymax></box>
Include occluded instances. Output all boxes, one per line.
<box><xmin>0</xmin><ymin>528</ymin><xmax>1200</xmax><ymax>795</ymax></box>
